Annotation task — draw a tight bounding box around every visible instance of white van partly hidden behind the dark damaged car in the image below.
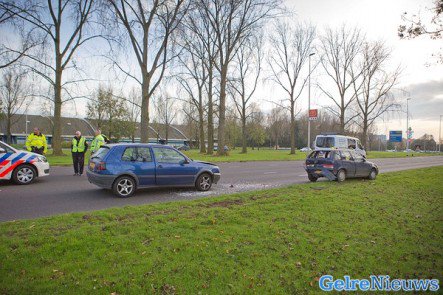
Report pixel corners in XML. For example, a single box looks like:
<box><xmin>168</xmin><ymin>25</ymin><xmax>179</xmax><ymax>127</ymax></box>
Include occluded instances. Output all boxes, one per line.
<box><xmin>314</xmin><ymin>135</ymin><xmax>366</xmax><ymax>157</ymax></box>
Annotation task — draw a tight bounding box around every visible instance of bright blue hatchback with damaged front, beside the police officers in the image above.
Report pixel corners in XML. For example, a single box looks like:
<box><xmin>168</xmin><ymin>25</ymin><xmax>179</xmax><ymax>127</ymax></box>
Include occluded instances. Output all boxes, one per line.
<box><xmin>86</xmin><ymin>143</ymin><xmax>220</xmax><ymax>198</ymax></box>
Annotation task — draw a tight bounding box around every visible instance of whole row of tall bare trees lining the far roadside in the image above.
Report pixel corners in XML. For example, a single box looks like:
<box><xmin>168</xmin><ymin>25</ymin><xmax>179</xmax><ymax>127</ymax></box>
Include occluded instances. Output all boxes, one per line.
<box><xmin>0</xmin><ymin>0</ymin><xmax>400</xmax><ymax>155</ymax></box>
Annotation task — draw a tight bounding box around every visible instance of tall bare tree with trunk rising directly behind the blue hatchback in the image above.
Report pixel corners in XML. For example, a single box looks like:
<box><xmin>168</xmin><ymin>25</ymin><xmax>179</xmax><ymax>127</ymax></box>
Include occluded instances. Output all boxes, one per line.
<box><xmin>108</xmin><ymin>0</ymin><xmax>189</xmax><ymax>142</ymax></box>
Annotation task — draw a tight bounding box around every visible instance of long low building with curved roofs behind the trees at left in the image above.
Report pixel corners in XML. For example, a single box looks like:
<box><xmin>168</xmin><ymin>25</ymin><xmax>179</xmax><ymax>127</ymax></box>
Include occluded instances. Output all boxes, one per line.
<box><xmin>0</xmin><ymin>114</ymin><xmax>189</xmax><ymax>146</ymax></box>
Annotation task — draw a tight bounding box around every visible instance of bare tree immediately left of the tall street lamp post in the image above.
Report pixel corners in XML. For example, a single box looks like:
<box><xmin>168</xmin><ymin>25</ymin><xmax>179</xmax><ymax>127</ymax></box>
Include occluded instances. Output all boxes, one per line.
<box><xmin>268</xmin><ymin>22</ymin><xmax>315</xmax><ymax>154</ymax></box>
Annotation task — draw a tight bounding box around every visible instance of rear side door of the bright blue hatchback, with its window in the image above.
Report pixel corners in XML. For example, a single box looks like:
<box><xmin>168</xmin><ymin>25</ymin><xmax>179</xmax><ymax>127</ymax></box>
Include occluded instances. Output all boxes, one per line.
<box><xmin>121</xmin><ymin>147</ymin><xmax>155</xmax><ymax>186</ymax></box>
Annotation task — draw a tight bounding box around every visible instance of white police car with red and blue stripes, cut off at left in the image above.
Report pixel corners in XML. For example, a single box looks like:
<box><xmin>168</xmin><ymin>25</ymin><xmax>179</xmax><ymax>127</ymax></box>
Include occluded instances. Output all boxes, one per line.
<box><xmin>0</xmin><ymin>141</ymin><xmax>49</xmax><ymax>184</ymax></box>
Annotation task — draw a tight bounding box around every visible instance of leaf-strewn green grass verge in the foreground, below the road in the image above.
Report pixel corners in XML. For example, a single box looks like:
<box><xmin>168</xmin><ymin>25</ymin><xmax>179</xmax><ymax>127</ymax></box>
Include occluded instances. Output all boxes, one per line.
<box><xmin>0</xmin><ymin>167</ymin><xmax>443</xmax><ymax>294</ymax></box>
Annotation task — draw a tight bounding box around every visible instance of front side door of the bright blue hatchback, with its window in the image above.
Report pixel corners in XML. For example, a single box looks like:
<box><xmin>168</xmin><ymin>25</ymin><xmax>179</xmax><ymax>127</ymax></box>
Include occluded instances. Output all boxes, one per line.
<box><xmin>152</xmin><ymin>147</ymin><xmax>197</xmax><ymax>185</ymax></box>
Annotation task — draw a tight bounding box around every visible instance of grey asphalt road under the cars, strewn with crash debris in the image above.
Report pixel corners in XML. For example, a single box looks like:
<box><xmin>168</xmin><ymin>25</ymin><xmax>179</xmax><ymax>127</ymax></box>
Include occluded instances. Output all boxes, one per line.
<box><xmin>0</xmin><ymin>156</ymin><xmax>443</xmax><ymax>221</ymax></box>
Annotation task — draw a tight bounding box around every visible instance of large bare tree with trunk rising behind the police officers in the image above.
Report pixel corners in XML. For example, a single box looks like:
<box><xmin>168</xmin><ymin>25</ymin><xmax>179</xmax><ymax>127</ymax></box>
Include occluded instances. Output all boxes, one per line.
<box><xmin>2</xmin><ymin>0</ymin><xmax>98</xmax><ymax>155</ymax></box>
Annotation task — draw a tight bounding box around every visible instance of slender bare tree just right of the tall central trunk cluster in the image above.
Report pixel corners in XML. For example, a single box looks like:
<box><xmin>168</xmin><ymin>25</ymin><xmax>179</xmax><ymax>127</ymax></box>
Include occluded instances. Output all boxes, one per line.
<box><xmin>229</xmin><ymin>34</ymin><xmax>263</xmax><ymax>153</ymax></box>
